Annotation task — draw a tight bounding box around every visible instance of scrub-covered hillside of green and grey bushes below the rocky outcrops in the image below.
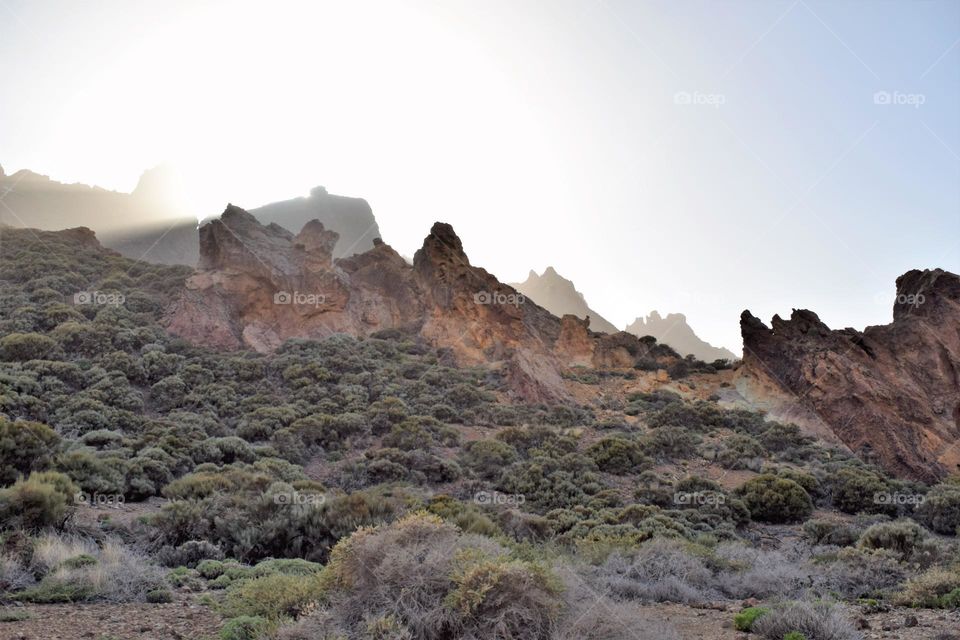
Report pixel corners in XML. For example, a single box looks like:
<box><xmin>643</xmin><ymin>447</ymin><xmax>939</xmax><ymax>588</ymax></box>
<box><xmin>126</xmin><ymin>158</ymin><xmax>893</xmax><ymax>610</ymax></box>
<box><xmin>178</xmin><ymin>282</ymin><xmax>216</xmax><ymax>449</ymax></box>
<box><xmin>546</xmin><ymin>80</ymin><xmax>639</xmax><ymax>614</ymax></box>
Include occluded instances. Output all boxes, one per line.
<box><xmin>0</xmin><ymin>225</ymin><xmax>960</xmax><ymax>640</ymax></box>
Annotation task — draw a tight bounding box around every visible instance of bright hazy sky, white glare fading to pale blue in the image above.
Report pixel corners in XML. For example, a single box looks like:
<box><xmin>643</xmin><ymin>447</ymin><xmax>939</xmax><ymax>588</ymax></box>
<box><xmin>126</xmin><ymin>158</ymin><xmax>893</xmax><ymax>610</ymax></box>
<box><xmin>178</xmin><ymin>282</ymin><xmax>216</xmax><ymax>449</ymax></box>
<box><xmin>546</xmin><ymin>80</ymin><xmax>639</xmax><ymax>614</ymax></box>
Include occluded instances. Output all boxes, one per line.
<box><xmin>0</xmin><ymin>0</ymin><xmax>960</xmax><ymax>353</ymax></box>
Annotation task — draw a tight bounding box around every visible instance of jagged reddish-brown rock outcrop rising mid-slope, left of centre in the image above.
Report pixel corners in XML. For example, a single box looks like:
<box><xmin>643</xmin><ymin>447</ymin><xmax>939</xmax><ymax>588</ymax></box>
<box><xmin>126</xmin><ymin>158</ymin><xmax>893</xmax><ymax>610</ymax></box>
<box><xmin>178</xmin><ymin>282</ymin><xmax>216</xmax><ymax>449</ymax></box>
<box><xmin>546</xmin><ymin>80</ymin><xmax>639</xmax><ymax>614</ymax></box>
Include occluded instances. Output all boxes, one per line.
<box><xmin>167</xmin><ymin>206</ymin><xmax>668</xmax><ymax>400</ymax></box>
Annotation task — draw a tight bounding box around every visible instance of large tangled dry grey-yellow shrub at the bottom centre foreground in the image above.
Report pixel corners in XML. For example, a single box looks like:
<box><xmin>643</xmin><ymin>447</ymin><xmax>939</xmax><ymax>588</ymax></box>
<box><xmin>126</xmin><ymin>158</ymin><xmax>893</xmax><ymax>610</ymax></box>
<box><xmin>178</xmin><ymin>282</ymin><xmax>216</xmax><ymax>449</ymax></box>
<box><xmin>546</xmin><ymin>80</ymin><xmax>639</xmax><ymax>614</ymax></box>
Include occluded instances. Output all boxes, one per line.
<box><xmin>296</xmin><ymin>514</ymin><xmax>560</xmax><ymax>640</ymax></box>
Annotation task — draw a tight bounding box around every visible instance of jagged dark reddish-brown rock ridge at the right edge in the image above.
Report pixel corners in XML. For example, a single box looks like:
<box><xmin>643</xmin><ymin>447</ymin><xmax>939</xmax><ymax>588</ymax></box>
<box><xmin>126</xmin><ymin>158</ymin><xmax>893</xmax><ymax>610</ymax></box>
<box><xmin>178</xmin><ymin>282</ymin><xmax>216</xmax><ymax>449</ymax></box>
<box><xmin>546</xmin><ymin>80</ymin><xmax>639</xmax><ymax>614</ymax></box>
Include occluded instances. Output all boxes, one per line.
<box><xmin>740</xmin><ymin>269</ymin><xmax>960</xmax><ymax>480</ymax></box>
